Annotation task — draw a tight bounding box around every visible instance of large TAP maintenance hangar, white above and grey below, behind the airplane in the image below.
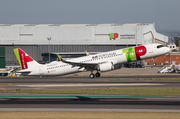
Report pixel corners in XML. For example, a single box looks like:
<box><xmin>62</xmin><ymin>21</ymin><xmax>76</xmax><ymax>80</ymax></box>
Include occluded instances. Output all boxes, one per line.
<box><xmin>0</xmin><ymin>23</ymin><xmax>168</xmax><ymax>65</ymax></box>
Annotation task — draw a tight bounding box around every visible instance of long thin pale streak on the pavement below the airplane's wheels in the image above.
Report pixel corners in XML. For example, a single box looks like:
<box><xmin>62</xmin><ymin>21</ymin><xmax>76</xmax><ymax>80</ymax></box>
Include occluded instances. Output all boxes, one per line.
<box><xmin>17</xmin><ymin>83</ymin><xmax>165</xmax><ymax>87</ymax></box>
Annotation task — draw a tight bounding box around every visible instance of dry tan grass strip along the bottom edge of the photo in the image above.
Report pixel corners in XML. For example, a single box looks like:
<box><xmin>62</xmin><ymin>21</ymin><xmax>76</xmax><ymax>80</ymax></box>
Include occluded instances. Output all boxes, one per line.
<box><xmin>0</xmin><ymin>111</ymin><xmax>180</xmax><ymax>119</ymax></box>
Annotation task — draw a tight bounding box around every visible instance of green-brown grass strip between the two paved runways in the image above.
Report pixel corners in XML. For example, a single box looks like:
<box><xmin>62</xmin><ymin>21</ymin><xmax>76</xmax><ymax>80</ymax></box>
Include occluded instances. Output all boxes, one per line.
<box><xmin>0</xmin><ymin>88</ymin><xmax>180</xmax><ymax>96</ymax></box>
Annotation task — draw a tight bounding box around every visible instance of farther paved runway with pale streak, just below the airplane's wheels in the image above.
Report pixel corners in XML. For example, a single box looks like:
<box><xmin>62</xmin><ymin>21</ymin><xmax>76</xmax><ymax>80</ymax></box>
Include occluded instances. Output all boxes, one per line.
<box><xmin>0</xmin><ymin>77</ymin><xmax>180</xmax><ymax>90</ymax></box>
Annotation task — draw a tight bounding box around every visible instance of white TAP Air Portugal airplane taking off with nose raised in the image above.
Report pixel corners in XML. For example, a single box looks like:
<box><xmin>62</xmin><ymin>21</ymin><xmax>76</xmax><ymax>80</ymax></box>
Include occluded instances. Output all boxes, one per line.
<box><xmin>13</xmin><ymin>43</ymin><xmax>170</xmax><ymax>78</ymax></box>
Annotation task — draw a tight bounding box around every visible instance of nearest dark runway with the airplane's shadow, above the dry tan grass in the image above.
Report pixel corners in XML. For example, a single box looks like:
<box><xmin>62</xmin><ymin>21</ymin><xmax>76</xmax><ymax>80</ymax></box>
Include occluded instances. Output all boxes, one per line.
<box><xmin>0</xmin><ymin>97</ymin><xmax>180</xmax><ymax>112</ymax></box>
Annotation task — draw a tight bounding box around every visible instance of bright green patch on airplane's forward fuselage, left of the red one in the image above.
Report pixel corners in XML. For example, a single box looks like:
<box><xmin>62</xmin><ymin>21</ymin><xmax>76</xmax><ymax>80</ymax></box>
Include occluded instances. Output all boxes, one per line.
<box><xmin>123</xmin><ymin>48</ymin><xmax>136</xmax><ymax>62</ymax></box>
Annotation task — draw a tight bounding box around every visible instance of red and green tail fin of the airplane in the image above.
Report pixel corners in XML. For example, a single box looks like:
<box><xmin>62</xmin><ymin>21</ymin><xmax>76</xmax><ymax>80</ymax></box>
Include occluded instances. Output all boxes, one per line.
<box><xmin>13</xmin><ymin>48</ymin><xmax>38</xmax><ymax>70</ymax></box>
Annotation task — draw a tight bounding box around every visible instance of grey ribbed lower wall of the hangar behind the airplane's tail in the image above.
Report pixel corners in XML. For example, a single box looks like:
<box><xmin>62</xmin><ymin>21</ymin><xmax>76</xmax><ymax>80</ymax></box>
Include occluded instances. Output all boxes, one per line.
<box><xmin>3</xmin><ymin>45</ymin><xmax>131</xmax><ymax>65</ymax></box>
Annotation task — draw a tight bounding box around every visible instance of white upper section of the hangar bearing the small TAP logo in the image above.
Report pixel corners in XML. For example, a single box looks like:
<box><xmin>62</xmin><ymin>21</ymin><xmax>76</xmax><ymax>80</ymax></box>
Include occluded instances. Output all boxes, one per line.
<box><xmin>0</xmin><ymin>23</ymin><xmax>168</xmax><ymax>45</ymax></box>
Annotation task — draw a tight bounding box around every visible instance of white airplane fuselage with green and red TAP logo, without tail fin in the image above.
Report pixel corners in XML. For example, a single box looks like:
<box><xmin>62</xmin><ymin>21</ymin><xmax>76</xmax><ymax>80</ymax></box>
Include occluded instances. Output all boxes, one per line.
<box><xmin>25</xmin><ymin>44</ymin><xmax>170</xmax><ymax>76</ymax></box>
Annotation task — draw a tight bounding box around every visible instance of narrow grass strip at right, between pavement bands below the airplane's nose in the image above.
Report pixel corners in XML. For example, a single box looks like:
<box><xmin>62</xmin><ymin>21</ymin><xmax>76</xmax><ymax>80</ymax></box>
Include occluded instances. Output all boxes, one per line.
<box><xmin>101</xmin><ymin>78</ymin><xmax>180</xmax><ymax>81</ymax></box>
